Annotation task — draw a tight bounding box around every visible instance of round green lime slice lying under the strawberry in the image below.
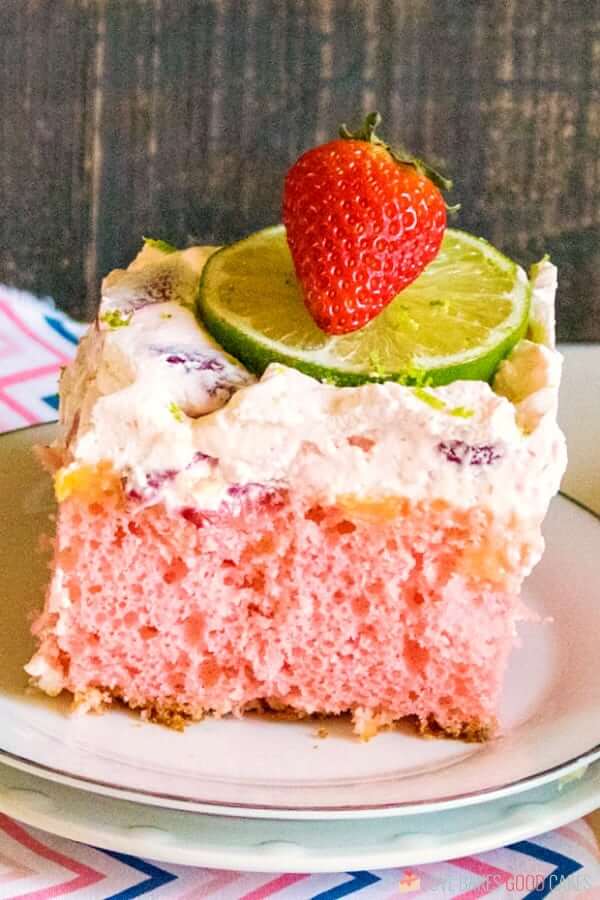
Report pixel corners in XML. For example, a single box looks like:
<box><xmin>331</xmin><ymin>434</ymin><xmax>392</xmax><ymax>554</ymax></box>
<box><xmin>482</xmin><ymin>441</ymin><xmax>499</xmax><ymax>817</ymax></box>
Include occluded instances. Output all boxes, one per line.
<box><xmin>198</xmin><ymin>225</ymin><xmax>531</xmax><ymax>385</ymax></box>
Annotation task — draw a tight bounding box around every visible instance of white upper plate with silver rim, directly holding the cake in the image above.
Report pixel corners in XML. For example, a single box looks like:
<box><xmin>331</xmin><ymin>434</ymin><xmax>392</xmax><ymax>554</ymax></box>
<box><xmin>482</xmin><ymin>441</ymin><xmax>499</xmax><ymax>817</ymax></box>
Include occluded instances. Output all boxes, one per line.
<box><xmin>0</xmin><ymin>426</ymin><xmax>600</xmax><ymax>819</ymax></box>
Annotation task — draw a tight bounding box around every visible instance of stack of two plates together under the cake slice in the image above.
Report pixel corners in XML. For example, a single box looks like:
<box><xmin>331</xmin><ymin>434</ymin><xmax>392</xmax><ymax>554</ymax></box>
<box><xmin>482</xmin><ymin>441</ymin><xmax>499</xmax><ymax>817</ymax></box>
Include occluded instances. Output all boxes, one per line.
<box><xmin>0</xmin><ymin>426</ymin><xmax>600</xmax><ymax>872</ymax></box>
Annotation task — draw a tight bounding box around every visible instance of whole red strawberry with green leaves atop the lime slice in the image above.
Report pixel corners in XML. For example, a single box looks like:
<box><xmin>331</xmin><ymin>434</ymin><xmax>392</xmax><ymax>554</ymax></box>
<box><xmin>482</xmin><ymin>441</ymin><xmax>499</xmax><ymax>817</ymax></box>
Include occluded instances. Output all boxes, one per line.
<box><xmin>283</xmin><ymin>113</ymin><xmax>452</xmax><ymax>334</ymax></box>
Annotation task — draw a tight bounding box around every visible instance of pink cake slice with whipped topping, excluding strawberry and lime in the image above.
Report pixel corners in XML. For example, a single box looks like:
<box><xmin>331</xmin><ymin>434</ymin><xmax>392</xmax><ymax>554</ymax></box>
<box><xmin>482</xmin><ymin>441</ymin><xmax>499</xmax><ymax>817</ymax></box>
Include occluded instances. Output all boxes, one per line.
<box><xmin>27</xmin><ymin>239</ymin><xmax>565</xmax><ymax>740</ymax></box>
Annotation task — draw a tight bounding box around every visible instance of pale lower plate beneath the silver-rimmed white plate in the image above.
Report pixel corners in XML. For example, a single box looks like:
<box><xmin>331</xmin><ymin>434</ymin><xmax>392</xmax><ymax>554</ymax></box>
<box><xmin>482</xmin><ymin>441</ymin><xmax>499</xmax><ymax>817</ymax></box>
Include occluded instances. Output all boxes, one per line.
<box><xmin>0</xmin><ymin>762</ymin><xmax>600</xmax><ymax>873</ymax></box>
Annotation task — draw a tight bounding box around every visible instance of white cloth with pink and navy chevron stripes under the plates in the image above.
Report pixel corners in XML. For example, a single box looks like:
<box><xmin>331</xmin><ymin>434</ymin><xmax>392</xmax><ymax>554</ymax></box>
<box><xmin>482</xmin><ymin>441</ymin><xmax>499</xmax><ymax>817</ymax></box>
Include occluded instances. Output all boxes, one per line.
<box><xmin>0</xmin><ymin>286</ymin><xmax>600</xmax><ymax>900</ymax></box>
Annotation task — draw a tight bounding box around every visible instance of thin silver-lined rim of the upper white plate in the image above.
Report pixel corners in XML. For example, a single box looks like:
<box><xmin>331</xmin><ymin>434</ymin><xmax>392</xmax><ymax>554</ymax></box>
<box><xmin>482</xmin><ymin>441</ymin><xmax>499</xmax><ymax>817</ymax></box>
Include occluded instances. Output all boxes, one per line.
<box><xmin>0</xmin><ymin>420</ymin><xmax>600</xmax><ymax>820</ymax></box>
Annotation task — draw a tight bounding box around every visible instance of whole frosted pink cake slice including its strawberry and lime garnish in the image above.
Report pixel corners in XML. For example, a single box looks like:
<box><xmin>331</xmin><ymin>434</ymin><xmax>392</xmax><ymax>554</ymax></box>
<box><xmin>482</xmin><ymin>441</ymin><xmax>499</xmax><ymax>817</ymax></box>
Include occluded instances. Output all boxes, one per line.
<box><xmin>27</xmin><ymin>114</ymin><xmax>565</xmax><ymax>740</ymax></box>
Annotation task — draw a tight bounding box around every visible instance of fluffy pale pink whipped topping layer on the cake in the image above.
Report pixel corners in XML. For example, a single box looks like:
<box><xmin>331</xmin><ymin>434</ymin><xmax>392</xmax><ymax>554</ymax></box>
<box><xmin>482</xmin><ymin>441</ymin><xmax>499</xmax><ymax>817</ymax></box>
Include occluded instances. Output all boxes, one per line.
<box><xmin>56</xmin><ymin>247</ymin><xmax>566</xmax><ymax>521</ymax></box>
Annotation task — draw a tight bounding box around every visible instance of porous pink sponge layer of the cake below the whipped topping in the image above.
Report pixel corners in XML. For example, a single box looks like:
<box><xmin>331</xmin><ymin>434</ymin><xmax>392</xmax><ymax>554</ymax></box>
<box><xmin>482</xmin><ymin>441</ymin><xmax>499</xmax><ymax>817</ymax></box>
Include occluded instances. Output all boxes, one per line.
<box><xmin>34</xmin><ymin>493</ymin><xmax>539</xmax><ymax>740</ymax></box>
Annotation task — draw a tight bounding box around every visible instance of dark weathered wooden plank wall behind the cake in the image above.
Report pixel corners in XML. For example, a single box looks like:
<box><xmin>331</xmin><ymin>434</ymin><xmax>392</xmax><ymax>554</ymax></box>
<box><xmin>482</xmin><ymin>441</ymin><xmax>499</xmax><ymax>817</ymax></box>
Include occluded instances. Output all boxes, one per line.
<box><xmin>0</xmin><ymin>0</ymin><xmax>600</xmax><ymax>340</ymax></box>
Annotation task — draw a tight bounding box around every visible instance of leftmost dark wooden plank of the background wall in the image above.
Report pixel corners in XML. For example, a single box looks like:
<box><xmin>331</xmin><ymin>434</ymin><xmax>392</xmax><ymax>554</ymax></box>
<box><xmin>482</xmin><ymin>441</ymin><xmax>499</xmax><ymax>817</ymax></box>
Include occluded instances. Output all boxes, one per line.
<box><xmin>0</xmin><ymin>0</ymin><xmax>97</xmax><ymax>314</ymax></box>
